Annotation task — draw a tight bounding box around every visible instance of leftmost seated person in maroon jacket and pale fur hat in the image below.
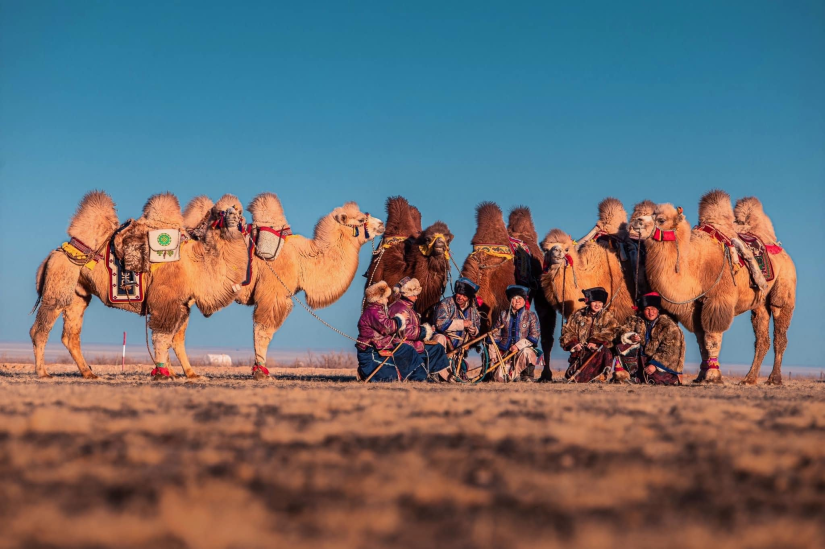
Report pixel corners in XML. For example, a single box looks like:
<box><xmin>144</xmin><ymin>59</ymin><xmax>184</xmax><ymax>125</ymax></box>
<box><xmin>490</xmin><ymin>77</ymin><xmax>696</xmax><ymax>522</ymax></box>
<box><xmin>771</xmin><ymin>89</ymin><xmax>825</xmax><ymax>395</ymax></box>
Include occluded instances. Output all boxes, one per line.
<box><xmin>355</xmin><ymin>281</ymin><xmax>427</xmax><ymax>381</ymax></box>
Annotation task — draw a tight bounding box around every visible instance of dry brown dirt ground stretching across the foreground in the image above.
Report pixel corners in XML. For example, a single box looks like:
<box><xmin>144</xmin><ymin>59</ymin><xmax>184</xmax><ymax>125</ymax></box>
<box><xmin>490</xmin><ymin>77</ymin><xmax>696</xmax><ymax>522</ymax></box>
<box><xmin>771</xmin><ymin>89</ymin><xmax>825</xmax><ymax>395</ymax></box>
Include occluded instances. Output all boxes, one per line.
<box><xmin>0</xmin><ymin>365</ymin><xmax>825</xmax><ymax>549</ymax></box>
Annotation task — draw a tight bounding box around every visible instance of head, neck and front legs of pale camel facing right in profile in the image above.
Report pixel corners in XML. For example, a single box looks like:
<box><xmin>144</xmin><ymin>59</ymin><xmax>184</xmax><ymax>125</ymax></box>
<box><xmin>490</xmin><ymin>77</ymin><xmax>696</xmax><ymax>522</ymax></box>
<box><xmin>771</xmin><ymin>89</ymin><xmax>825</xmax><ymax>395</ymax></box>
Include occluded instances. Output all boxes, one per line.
<box><xmin>236</xmin><ymin>202</ymin><xmax>384</xmax><ymax>370</ymax></box>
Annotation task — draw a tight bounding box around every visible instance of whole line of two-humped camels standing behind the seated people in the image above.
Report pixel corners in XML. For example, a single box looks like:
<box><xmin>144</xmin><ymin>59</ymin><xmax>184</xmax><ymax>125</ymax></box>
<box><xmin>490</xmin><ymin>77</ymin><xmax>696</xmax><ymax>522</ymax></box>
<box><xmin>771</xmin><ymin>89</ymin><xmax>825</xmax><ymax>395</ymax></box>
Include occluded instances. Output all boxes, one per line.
<box><xmin>30</xmin><ymin>190</ymin><xmax>796</xmax><ymax>384</ymax></box>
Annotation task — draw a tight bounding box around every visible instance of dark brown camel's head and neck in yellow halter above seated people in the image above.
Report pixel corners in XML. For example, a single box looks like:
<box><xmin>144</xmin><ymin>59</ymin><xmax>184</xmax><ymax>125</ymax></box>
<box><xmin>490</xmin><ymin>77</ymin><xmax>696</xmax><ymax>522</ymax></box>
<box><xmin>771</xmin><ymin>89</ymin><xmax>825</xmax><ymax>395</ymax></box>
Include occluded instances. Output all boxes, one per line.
<box><xmin>408</xmin><ymin>217</ymin><xmax>453</xmax><ymax>312</ymax></box>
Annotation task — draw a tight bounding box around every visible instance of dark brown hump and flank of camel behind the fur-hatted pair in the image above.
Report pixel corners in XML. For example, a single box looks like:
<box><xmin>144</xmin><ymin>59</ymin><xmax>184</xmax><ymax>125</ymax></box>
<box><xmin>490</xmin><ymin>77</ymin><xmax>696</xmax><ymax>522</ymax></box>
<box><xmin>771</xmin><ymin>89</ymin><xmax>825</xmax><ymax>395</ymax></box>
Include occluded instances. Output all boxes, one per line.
<box><xmin>364</xmin><ymin>196</ymin><xmax>421</xmax><ymax>288</ymax></box>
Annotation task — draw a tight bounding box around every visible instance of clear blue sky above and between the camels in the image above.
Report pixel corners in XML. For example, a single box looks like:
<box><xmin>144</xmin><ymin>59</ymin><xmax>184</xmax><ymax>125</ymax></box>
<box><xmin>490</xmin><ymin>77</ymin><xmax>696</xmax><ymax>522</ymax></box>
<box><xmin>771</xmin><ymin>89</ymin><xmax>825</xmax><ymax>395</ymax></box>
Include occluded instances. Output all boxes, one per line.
<box><xmin>0</xmin><ymin>0</ymin><xmax>825</xmax><ymax>365</ymax></box>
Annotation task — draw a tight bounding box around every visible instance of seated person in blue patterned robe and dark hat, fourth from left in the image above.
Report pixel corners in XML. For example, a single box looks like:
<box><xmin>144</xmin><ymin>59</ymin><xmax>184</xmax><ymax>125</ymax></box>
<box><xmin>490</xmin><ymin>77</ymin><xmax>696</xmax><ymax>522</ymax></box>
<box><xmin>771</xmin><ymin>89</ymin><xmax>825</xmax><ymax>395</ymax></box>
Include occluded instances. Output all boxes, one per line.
<box><xmin>488</xmin><ymin>285</ymin><xmax>539</xmax><ymax>381</ymax></box>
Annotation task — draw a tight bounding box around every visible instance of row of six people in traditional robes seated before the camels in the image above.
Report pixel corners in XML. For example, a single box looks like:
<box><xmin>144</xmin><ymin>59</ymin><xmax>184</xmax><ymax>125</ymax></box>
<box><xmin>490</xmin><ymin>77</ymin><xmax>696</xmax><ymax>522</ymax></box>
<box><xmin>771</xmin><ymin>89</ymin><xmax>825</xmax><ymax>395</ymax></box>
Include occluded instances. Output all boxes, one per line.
<box><xmin>356</xmin><ymin>277</ymin><xmax>685</xmax><ymax>385</ymax></box>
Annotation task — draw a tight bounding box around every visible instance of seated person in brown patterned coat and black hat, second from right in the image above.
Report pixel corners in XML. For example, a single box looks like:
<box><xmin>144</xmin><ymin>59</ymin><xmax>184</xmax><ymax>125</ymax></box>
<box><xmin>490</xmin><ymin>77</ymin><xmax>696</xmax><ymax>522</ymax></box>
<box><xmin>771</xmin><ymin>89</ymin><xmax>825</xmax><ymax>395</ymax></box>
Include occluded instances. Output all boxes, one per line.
<box><xmin>559</xmin><ymin>287</ymin><xmax>619</xmax><ymax>383</ymax></box>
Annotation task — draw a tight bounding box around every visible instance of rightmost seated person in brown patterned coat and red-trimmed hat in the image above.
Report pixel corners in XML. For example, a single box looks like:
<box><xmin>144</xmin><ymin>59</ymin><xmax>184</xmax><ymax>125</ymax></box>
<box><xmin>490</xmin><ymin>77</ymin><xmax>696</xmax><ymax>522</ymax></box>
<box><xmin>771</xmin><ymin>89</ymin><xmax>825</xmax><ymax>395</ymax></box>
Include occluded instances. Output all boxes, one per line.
<box><xmin>614</xmin><ymin>292</ymin><xmax>685</xmax><ymax>385</ymax></box>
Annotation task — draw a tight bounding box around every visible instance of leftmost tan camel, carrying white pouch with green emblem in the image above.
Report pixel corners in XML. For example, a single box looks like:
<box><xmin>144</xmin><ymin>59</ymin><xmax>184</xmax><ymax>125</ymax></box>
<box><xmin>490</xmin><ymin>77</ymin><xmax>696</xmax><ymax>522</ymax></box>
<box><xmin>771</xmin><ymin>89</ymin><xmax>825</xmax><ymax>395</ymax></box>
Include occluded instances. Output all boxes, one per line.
<box><xmin>30</xmin><ymin>191</ymin><xmax>247</xmax><ymax>379</ymax></box>
